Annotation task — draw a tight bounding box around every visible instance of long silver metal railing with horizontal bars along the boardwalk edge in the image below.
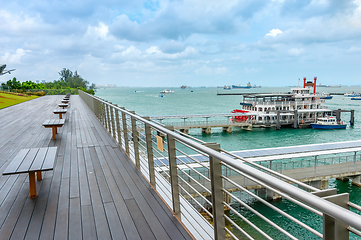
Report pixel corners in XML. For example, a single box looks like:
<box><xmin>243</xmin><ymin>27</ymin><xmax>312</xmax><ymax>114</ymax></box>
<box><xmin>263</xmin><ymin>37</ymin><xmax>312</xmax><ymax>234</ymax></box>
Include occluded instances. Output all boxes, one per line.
<box><xmin>79</xmin><ymin>91</ymin><xmax>361</xmax><ymax>239</ymax></box>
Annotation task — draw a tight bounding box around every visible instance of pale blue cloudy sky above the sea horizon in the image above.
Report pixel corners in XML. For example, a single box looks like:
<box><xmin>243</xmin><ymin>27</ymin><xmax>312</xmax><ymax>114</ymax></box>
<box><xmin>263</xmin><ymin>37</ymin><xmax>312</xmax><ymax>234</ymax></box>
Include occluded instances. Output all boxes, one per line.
<box><xmin>0</xmin><ymin>0</ymin><xmax>361</xmax><ymax>87</ymax></box>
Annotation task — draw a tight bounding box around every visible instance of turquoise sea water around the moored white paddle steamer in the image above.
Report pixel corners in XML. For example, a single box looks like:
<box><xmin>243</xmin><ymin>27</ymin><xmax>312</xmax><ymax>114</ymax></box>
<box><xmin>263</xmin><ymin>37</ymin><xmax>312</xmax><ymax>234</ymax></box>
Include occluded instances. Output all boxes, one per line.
<box><xmin>96</xmin><ymin>87</ymin><xmax>361</xmax><ymax>239</ymax></box>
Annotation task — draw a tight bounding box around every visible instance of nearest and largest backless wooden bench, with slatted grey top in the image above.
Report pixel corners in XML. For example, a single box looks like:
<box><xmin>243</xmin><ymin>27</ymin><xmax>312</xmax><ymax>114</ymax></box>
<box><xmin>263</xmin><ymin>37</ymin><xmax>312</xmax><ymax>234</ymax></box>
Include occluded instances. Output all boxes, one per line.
<box><xmin>3</xmin><ymin>147</ymin><xmax>57</xmax><ymax>198</ymax></box>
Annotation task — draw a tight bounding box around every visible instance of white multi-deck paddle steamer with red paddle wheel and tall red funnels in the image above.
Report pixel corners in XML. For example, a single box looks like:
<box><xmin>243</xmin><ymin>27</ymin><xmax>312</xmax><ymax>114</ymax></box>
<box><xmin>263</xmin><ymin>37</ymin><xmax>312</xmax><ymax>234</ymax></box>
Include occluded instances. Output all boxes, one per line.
<box><xmin>232</xmin><ymin>78</ymin><xmax>332</xmax><ymax>127</ymax></box>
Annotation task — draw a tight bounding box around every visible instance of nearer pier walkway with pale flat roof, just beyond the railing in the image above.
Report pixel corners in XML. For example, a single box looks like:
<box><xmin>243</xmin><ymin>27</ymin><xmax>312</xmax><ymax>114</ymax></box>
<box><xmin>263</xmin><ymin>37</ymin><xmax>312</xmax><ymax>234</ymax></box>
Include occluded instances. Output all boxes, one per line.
<box><xmin>158</xmin><ymin>141</ymin><xmax>361</xmax><ymax>201</ymax></box>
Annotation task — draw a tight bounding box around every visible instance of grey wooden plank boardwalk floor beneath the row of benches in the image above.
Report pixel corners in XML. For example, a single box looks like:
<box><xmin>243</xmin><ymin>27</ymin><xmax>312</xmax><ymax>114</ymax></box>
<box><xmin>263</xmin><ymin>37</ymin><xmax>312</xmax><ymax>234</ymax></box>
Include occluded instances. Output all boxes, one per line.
<box><xmin>0</xmin><ymin>96</ymin><xmax>192</xmax><ymax>240</ymax></box>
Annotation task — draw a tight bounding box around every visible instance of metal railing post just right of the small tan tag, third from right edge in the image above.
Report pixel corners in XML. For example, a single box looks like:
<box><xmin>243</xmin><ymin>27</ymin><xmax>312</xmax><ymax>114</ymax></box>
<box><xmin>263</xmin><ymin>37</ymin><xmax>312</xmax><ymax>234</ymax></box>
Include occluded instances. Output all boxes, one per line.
<box><xmin>166</xmin><ymin>125</ymin><xmax>181</xmax><ymax>219</ymax></box>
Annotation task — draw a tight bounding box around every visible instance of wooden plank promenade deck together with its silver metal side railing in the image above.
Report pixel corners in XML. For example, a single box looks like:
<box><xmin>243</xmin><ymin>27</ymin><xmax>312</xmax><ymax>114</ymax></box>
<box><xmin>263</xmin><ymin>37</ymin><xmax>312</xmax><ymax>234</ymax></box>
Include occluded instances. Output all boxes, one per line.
<box><xmin>0</xmin><ymin>91</ymin><xmax>361</xmax><ymax>239</ymax></box>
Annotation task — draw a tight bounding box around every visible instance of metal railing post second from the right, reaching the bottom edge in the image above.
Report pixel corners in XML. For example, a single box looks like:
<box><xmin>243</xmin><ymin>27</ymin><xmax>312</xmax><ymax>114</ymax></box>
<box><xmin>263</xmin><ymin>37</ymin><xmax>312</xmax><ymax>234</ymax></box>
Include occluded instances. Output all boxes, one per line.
<box><xmin>204</xmin><ymin>143</ymin><xmax>226</xmax><ymax>240</ymax></box>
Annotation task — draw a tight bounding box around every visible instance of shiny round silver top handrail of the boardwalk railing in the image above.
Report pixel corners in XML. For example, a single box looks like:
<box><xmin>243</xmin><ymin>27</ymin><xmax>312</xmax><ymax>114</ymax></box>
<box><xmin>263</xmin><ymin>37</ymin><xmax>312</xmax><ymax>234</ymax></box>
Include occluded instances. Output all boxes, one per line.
<box><xmin>81</xmin><ymin>92</ymin><xmax>361</xmax><ymax>237</ymax></box>
